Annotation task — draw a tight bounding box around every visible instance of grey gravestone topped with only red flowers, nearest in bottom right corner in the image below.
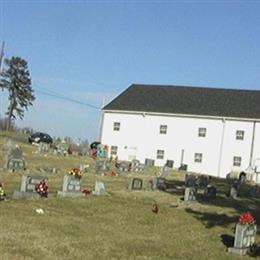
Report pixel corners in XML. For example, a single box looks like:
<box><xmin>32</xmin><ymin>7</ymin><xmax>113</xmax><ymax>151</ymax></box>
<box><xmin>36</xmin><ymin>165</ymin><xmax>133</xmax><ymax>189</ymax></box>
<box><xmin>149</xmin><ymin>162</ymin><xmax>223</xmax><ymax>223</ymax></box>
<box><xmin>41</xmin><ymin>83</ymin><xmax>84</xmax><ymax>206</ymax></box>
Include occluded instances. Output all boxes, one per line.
<box><xmin>228</xmin><ymin>223</ymin><xmax>257</xmax><ymax>255</ymax></box>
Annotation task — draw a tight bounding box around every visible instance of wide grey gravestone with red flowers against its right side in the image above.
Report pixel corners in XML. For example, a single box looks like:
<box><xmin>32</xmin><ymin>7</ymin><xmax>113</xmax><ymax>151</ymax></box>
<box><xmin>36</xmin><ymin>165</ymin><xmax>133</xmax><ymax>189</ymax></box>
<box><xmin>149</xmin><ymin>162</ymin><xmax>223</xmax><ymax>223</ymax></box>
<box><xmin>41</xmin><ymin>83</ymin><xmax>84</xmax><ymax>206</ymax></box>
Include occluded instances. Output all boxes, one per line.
<box><xmin>13</xmin><ymin>175</ymin><xmax>48</xmax><ymax>199</ymax></box>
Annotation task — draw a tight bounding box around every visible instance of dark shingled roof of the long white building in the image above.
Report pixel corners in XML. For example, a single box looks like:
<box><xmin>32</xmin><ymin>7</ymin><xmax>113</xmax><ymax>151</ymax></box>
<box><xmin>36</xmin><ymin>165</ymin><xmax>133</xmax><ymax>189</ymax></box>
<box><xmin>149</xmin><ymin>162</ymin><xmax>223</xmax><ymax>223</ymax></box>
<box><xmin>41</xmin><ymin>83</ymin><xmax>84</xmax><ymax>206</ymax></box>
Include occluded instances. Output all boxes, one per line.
<box><xmin>103</xmin><ymin>84</ymin><xmax>260</xmax><ymax>119</ymax></box>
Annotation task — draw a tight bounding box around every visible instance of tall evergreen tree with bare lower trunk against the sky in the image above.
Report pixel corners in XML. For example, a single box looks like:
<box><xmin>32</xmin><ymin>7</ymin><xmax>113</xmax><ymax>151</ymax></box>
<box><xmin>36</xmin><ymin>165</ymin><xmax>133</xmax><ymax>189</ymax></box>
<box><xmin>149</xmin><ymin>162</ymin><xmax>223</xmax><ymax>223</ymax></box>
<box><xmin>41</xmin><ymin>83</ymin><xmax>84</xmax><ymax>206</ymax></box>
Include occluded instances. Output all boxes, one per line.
<box><xmin>0</xmin><ymin>57</ymin><xmax>35</xmax><ymax>130</ymax></box>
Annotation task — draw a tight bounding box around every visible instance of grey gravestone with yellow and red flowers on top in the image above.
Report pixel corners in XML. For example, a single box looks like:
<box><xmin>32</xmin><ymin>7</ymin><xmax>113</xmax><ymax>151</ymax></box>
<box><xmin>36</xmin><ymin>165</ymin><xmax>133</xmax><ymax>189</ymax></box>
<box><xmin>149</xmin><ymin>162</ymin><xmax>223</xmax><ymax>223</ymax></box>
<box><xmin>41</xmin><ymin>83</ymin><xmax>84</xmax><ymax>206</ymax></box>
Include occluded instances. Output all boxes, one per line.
<box><xmin>58</xmin><ymin>175</ymin><xmax>84</xmax><ymax>197</ymax></box>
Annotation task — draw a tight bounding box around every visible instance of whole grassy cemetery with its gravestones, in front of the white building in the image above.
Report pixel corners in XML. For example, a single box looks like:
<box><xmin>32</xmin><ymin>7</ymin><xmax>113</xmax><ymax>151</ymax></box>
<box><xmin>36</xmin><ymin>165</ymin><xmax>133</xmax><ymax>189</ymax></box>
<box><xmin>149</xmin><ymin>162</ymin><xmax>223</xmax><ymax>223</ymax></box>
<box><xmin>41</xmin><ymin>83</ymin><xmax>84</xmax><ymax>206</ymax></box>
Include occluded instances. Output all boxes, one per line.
<box><xmin>0</xmin><ymin>133</ymin><xmax>260</xmax><ymax>259</ymax></box>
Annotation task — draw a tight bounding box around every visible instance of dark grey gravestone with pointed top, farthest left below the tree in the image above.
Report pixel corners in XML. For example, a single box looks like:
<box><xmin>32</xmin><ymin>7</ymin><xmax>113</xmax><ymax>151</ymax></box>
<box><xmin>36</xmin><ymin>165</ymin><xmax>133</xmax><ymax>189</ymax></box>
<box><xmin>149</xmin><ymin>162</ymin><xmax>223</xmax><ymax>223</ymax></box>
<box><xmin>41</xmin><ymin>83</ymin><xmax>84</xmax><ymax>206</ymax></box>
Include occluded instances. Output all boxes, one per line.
<box><xmin>5</xmin><ymin>145</ymin><xmax>26</xmax><ymax>171</ymax></box>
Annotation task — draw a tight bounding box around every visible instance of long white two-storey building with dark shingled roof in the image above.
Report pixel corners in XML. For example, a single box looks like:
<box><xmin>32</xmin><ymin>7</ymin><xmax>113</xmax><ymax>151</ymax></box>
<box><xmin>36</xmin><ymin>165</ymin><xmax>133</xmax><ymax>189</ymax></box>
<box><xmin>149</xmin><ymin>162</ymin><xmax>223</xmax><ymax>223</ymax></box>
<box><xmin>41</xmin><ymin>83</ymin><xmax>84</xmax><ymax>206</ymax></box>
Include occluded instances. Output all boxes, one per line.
<box><xmin>101</xmin><ymin>84</ymin><xmax>260</xmax><ymax>180</ymax></box>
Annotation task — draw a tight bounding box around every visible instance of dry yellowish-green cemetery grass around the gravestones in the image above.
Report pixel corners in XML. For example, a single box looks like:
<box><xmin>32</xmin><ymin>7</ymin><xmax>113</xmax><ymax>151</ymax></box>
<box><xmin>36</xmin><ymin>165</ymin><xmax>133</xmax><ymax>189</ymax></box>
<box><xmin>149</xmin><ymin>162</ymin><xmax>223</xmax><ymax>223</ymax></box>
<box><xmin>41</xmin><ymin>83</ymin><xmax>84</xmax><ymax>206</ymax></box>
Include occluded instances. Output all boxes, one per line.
<box><xmin>0</xmin><ymin>132</ymin><xmax>260</xmax><ymax>260</ymax></box>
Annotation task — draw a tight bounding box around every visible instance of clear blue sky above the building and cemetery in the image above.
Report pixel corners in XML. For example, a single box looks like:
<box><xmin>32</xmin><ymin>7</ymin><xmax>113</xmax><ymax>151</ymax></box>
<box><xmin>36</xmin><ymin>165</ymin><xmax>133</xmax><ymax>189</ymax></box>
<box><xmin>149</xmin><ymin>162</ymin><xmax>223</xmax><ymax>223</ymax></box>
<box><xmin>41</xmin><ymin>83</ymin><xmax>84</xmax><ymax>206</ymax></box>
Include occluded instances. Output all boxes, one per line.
<box><xmin>0</xmin><ymin>0</ymin><xmax>260</xmax><ymax>141</ymax></box>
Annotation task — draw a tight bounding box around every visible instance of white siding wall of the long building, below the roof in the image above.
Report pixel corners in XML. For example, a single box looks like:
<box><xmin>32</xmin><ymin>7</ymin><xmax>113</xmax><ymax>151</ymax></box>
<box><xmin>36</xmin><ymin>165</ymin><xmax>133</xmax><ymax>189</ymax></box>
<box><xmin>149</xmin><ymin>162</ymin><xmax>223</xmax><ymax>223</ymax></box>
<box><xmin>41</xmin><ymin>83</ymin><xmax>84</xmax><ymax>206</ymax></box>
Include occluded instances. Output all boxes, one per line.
<box><xmin>101</xmin><ymin>112</ymin><xmax>260</xmax><ymax>177</ymax></box>
